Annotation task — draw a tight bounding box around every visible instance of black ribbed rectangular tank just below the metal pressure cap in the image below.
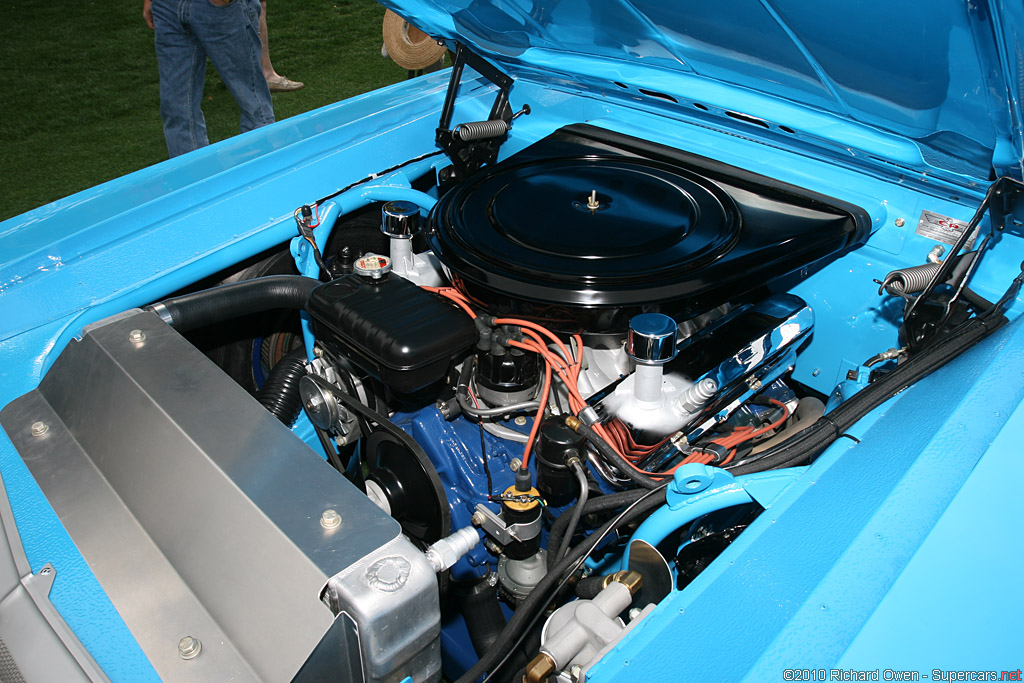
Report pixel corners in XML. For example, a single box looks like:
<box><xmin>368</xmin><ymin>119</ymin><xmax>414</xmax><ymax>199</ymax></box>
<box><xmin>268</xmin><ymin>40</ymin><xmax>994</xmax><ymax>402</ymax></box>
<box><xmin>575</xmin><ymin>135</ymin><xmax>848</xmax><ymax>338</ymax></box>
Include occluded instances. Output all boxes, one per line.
<box><xmin>308</xmin><ymin>274</ymin><xmax>476</xmax><ymax>393</ymax></box>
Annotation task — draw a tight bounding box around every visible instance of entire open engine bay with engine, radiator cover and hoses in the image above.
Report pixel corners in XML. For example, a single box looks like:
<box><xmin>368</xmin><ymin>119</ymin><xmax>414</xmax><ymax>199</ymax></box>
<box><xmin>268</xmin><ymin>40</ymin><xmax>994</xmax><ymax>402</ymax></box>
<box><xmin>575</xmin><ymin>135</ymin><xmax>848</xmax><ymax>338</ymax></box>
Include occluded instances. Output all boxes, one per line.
<box><xmin>0</xmin><ymin>50</ymin><xmax>1024</xmax><ymax>683</ymax></box>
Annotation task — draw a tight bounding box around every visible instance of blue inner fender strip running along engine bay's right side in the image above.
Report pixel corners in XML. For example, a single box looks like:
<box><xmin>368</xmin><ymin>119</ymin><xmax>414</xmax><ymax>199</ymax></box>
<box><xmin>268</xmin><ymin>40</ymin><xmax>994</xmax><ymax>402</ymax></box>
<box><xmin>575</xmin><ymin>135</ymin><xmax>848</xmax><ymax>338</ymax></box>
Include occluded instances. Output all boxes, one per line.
<box><xmin>592</xmin><ymin>323</ymin><xmax>1024</xmax><ymax>681</ymax></box>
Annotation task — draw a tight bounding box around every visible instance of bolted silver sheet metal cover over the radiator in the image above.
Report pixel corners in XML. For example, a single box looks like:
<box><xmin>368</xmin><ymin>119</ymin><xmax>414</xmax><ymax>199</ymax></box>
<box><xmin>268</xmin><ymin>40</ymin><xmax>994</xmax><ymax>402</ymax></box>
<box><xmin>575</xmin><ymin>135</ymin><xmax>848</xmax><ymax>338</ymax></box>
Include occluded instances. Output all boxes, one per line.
<box><xmin>0</xmin><ymin>310</ymin><xmax>436</xmax><ymax>681</ymax></box>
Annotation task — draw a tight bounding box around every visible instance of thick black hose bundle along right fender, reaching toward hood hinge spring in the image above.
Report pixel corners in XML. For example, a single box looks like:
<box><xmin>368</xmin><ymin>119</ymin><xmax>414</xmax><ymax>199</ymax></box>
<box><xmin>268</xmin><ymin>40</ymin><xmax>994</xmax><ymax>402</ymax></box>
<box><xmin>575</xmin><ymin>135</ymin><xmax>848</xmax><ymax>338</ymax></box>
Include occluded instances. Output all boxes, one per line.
<box><xmin>729</xmin><ymin>316</ymin><xmax>1006</xmax><ymax>475</ymax></box>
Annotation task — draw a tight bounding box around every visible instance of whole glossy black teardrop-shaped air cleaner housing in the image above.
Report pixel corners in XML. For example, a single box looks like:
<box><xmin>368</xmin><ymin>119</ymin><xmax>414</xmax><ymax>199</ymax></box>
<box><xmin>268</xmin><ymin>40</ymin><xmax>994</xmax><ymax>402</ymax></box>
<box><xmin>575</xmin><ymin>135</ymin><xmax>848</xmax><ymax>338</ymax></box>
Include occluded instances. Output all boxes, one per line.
<box><xmin>428</xmin><ymin>125</ymin><xmax>869</xmax><ymax>333</ymax></box>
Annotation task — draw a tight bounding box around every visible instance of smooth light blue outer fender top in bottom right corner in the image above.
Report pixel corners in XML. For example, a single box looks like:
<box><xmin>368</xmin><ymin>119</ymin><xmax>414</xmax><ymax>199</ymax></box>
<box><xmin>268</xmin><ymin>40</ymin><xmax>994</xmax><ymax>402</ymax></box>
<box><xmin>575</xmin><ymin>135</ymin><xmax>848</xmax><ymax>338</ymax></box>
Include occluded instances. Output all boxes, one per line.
<box><xmin>836</xmin><ymin>405</ymin><xmax>1024</xmax><ymax>679</ymax></box>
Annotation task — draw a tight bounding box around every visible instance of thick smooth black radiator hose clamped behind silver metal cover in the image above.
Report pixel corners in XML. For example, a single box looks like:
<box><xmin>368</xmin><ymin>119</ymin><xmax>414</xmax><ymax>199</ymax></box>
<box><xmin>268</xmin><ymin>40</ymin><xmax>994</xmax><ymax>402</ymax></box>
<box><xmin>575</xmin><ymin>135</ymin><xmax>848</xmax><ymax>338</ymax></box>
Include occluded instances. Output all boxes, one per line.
<box><xmin>146</xmin><ymin>275</ymin><xmax>321</xmax><ymax>332</ymax></box>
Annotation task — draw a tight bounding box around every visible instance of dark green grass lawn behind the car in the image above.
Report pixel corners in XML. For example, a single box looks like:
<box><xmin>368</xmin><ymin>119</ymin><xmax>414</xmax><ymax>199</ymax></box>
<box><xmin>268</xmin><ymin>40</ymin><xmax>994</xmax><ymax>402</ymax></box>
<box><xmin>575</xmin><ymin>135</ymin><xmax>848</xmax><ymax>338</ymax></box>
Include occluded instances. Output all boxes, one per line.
<box><xmin>0</xmin><ymin>0</ymin><xmax>407</xmax><ymax>220</ymax></box>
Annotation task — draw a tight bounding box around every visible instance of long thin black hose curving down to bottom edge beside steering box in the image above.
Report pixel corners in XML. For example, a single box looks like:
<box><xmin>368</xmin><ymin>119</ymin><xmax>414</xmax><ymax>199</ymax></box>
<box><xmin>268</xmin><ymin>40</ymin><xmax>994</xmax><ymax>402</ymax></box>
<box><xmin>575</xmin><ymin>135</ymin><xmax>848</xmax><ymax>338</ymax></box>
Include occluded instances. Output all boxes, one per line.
<box><xmin>457</xmin><ymin>486</ymin><xmax>665</xmax><ymax>683</ymax></box>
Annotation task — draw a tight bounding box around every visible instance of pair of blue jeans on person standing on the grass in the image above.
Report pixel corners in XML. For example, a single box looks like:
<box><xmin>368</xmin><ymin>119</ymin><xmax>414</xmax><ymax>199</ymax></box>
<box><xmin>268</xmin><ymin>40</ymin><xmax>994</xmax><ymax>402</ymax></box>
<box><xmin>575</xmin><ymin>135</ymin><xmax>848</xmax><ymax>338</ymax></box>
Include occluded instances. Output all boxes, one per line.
<box><xmin>153</xmin><ymin>0</ymin><xmax>273</xmax><ymax>157</ymax></box>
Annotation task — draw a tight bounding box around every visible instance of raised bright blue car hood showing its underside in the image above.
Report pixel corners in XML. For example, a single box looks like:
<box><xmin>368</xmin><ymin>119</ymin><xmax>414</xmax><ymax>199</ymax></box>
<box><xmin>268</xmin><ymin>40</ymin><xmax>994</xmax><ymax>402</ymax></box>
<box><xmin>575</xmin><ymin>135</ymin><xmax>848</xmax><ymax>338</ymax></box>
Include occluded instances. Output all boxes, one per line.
<box><xmin>385</xmin><ymin>0</ymin><xmax>1024</xmax><ymax>183</ymax></box>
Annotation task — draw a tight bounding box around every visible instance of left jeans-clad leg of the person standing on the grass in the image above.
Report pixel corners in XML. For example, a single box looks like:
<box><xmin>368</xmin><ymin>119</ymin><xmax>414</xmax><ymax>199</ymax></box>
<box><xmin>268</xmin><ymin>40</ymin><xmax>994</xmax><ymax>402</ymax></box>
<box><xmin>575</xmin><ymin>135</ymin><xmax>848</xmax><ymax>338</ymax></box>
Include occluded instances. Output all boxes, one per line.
<box><xmin>153</xmin><ymin>0</ymin><xmax>210</xmax><ymax>157</ymax></box>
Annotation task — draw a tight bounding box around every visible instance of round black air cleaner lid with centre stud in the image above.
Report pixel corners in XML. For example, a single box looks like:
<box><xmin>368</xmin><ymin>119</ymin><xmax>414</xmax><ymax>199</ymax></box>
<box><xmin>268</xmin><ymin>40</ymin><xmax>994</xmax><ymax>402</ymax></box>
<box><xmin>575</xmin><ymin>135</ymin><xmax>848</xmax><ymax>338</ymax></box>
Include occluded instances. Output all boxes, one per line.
<box><xmin>430</xmin><ymin>157</ymin><xmax>739</xmax><ymax>315</ymax></box>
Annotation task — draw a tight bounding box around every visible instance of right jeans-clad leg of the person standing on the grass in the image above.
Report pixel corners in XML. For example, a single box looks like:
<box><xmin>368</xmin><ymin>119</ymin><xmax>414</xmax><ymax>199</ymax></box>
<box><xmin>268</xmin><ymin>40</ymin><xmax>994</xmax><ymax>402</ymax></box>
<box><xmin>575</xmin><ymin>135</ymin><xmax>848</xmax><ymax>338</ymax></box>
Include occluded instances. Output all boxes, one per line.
<box><xmin>189</xmin><ymin>0</ymin><xmax>273</xmax><ymax>132</ymax></box>
